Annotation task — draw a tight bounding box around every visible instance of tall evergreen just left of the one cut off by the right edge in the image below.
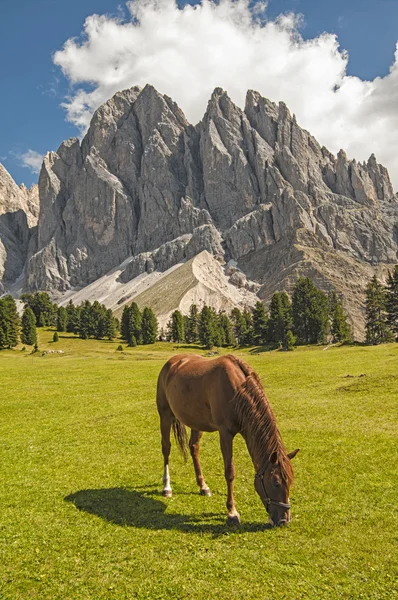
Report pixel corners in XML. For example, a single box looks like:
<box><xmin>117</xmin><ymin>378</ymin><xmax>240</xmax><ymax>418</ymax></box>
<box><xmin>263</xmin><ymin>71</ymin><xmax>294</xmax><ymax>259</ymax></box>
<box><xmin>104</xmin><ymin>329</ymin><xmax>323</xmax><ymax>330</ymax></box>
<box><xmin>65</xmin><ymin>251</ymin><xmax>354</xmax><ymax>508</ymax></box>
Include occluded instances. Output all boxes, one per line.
<box><xmin>365</xmin><ymin>275</ymin><xmax>393</xmax><ymax>344</ymax></box>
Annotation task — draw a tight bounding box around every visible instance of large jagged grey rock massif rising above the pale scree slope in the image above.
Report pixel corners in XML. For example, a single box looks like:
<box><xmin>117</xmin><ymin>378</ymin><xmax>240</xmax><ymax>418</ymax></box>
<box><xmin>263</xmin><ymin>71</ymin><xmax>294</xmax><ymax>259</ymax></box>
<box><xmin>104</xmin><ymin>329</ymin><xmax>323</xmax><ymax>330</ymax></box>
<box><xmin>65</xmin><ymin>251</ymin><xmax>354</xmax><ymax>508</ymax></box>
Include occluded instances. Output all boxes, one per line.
<box><xmin>0</xmin><ymin>85</ymin><xmax>398</xmax><ymax>338</ymax></box>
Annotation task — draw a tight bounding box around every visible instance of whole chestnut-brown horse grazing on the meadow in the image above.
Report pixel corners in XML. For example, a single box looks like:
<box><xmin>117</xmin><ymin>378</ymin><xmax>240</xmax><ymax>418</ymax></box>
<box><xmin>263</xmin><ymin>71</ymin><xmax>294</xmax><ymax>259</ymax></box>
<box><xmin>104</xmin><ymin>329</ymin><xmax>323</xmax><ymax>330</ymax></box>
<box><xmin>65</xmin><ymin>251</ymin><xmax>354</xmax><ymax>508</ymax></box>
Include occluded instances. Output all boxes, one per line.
<box><xmin>157</xmin><ymin>354</ymin><xmax>298</xmax><ymax>525</ymax></box>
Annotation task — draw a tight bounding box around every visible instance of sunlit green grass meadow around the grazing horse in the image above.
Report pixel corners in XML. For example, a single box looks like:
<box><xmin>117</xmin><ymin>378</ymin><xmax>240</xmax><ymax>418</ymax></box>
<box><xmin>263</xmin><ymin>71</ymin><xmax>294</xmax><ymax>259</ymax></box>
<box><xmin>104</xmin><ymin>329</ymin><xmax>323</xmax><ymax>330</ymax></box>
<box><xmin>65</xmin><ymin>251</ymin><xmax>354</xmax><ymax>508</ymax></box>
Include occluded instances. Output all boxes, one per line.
<box><xmin>0</xmin><ymin>331</ymin><xmax>398</xmax><ymax>600</ymax></box>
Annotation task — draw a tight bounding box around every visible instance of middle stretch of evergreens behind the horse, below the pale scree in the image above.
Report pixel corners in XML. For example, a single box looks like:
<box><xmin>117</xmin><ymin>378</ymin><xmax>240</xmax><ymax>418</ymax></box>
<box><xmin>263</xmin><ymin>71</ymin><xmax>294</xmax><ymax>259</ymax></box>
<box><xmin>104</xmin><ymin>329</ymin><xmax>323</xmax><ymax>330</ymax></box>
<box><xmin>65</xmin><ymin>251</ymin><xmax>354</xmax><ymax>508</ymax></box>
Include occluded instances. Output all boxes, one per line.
<box><xmin>162</xmin><ymin>277</ymin><xmax>352</xmax><ymax>350</ymax></box>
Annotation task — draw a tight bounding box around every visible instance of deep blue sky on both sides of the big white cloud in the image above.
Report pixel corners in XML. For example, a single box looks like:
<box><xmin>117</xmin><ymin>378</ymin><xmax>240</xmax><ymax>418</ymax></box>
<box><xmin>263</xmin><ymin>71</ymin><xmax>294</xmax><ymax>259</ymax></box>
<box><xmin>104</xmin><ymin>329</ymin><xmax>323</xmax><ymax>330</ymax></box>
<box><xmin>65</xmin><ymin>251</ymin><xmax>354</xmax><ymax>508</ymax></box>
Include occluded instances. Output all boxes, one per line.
<box><xmin>0</xmin><ymin>0</ymin><xmax>398</xmax><ymax>185</ymax></box>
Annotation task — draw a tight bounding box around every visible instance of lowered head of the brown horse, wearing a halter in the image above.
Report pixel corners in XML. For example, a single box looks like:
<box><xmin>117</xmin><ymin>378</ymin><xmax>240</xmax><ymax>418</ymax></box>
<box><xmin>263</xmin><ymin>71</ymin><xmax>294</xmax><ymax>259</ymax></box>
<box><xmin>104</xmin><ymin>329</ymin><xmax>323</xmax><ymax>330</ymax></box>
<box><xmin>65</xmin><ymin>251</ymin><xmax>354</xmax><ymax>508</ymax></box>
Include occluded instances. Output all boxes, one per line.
<box><xmin>254</xmin><ymin>448</ymin><xmax>299</xmax><ymax>525</ymax></box>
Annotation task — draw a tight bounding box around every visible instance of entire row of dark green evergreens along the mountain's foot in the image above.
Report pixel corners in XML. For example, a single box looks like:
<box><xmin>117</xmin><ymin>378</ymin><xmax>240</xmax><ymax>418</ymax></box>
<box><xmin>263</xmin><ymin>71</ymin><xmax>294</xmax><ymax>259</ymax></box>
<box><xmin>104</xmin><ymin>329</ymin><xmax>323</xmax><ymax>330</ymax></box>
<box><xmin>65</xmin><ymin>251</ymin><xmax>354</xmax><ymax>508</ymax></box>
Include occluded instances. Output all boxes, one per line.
<box><xmin>0</xmin><ymin>265</ymin><xmax>398</xmax><ymax>350</ymax></box>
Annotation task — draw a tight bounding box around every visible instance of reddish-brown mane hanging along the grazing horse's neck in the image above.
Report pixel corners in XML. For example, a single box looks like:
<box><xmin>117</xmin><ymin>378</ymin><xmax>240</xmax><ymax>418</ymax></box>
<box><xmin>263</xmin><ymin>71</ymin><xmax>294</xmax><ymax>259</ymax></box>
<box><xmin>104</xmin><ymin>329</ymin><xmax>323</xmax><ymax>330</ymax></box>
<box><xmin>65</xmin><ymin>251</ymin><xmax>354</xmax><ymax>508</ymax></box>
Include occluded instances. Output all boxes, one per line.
<box><xmin>230</xmin><ymin>355</ymin><xmax>293</xmax><ymax>485</ymax></box>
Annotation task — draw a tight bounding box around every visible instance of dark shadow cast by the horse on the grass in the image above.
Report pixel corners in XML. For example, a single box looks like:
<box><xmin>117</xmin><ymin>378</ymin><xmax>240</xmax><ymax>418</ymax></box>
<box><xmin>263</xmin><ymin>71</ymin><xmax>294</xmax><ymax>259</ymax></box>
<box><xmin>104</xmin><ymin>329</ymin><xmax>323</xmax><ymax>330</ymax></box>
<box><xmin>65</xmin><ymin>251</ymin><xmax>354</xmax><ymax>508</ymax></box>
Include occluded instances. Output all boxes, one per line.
<box><xmin>65</xmin><ymin>488</ymin><xmax>271</xmax><ymax>537</ymax></box>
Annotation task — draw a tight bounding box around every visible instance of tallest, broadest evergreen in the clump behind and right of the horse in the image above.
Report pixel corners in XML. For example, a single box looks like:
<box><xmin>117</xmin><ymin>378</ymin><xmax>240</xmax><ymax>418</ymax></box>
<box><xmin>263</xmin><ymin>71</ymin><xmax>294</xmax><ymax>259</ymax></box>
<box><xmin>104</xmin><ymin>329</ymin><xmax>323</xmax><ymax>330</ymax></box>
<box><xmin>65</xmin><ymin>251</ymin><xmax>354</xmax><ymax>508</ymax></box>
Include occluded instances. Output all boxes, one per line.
<box><xmin>292</xmin><ymin>277</ymin><xmax>329</xmax><ymax>344</ymax></box>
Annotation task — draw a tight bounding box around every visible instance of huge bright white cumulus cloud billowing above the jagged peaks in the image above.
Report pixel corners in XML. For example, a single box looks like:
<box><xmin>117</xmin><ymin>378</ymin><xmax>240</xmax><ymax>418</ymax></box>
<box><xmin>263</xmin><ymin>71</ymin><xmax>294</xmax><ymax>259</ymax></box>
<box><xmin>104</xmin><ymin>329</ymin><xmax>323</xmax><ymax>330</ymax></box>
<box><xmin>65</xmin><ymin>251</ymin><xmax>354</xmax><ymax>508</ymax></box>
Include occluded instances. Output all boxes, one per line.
<box><xmin>53</xmin><ymin>0</ymin><xmax>398</xmax><ymax>187</ymax></box>
